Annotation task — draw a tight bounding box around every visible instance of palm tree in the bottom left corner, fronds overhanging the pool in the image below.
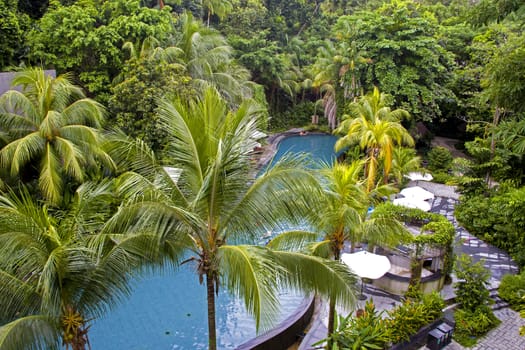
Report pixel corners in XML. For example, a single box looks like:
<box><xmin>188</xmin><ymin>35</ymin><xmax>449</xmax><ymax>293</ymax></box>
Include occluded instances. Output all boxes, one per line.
<box><xmin>0</xmin><ymin>182</ymin><xmax>165</xmax><ymax>350</ymax></box>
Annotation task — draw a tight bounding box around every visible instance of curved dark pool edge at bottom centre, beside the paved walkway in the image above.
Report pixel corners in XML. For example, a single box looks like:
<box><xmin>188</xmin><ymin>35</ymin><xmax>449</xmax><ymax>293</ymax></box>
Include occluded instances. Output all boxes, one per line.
<box><xmin>236</xmin><ymin>296</ymin><xmax>315</xmax><ymax>350</ymax></box>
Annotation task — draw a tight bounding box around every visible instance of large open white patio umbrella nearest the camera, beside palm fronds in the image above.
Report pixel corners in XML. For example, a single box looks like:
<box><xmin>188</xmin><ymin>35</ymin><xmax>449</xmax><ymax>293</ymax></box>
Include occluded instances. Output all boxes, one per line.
<box><xmin>341</xmin><ymin>251</ymin><xmax>391</xmax><ymax>300</ymax></box>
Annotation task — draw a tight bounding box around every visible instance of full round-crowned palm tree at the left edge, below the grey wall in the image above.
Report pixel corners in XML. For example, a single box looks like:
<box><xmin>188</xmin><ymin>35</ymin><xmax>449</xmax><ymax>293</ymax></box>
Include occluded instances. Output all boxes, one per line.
<box><xmin>0</xmin><ymin>68</ymin><xmax>112</xmax><ymax>205</ymax></box>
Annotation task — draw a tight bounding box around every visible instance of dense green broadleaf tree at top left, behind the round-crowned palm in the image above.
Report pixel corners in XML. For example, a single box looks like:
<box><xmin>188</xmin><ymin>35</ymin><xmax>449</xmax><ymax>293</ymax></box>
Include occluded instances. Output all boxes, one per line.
<box><xmin>27</xmin><ymin>0</ymin><xmax>173</xmax><ymax>102</ymax></box>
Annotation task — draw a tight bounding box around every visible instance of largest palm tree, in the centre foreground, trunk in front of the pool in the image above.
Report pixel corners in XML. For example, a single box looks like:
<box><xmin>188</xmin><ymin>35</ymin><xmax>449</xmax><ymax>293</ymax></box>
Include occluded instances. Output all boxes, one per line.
<box><xmin>113</xmin><ymin>88</ymin><xmax>355</xmax><ymax>349</ymax></box>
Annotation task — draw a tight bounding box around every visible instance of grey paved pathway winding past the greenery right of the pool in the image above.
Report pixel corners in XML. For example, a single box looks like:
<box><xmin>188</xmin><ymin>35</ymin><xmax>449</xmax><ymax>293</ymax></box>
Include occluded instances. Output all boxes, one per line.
<box><xmin>299</xmin><ymin>181</ymin><xmax>525</xmax><ymax>350</ymax></box>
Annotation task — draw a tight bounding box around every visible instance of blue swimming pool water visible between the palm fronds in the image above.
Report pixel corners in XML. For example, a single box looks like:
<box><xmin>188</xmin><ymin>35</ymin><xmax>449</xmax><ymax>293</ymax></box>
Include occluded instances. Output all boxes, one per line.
<box><xmin>89</xmin><ymin>135</ymin><xmax>336</xmax><ymax>350</ymax></box>
